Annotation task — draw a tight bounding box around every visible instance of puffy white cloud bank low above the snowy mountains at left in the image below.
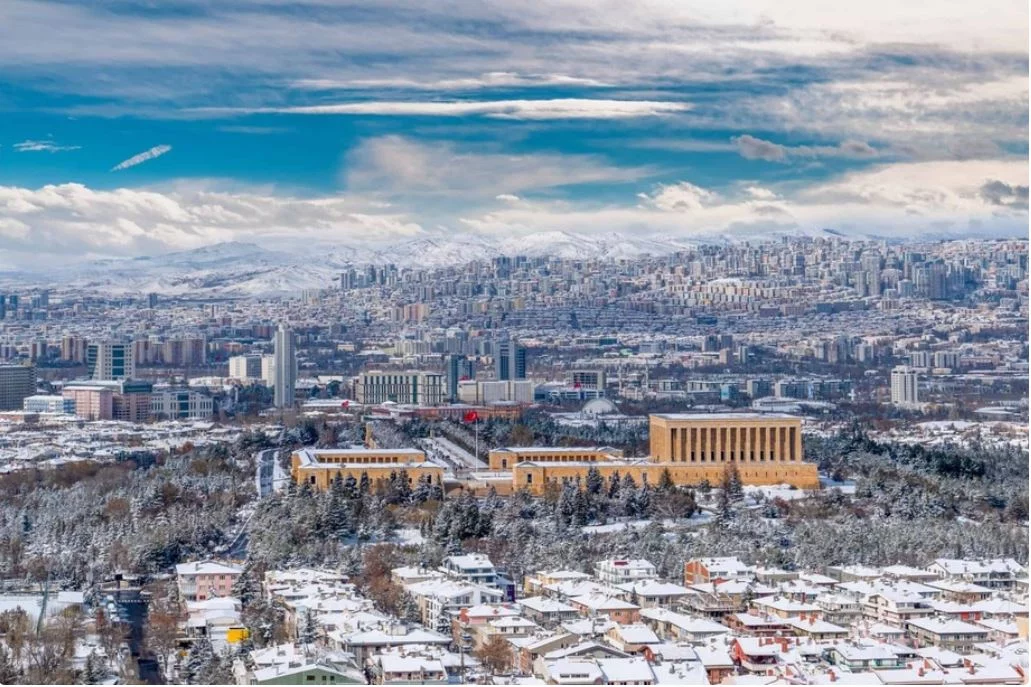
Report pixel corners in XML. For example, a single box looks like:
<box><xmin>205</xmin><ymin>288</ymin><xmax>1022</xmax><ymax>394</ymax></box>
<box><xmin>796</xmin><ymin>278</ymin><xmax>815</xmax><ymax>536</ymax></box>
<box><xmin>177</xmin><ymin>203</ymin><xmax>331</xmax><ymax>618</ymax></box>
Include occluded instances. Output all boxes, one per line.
<box><xmin>0</xmin><ymin>184</ymin><xmax>422</xmax><ymax>259</ymax></box>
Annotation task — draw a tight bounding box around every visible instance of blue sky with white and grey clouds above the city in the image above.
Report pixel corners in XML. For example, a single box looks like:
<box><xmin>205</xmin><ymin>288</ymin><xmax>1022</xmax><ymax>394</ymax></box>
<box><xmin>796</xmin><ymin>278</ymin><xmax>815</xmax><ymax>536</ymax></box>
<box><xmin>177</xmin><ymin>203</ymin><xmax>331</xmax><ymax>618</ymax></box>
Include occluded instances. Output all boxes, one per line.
<box><xmin>0</xmin><ymin>0</ymin><xmax>1028</xmax><ymax>266</ymax></box>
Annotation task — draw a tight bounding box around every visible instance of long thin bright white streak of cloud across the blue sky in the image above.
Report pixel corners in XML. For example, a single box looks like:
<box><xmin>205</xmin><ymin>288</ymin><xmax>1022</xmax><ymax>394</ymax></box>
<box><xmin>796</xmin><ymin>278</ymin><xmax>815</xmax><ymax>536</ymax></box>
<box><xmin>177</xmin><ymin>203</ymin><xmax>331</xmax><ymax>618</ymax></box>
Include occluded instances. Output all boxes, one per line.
<box><xmin>221</xmin><ymin>98</ymin><xmax>691</xmax><ymax>120</ymax></box>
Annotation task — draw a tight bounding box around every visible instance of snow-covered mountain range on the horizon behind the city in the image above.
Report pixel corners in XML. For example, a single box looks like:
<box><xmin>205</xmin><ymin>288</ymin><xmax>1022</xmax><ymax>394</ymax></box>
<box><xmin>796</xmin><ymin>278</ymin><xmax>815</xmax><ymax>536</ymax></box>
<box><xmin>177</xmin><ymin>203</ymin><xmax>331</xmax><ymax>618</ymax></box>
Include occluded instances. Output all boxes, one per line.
<box><xmin>0</xmin><ymin>228</ymin><xmax>1002</xmax><ymax>297</ymax></box>
